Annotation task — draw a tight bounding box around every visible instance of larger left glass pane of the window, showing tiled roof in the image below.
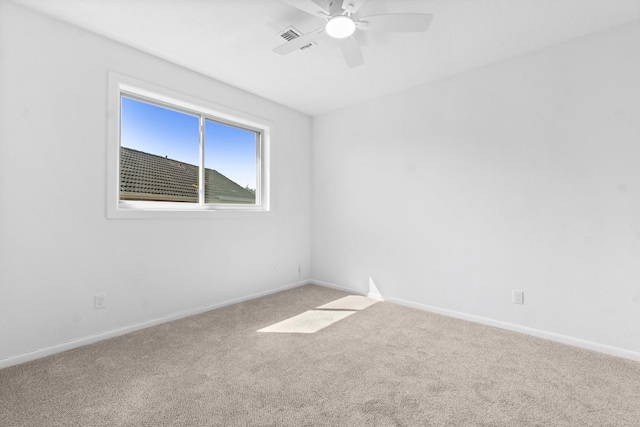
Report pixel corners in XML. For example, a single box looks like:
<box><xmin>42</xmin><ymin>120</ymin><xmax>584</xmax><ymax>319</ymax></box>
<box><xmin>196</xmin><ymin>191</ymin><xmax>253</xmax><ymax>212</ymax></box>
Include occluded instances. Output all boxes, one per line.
<box><xmin>120</xmin><ymin>96</ymin><xmax>200</xmax><ymax>203</ymax></box>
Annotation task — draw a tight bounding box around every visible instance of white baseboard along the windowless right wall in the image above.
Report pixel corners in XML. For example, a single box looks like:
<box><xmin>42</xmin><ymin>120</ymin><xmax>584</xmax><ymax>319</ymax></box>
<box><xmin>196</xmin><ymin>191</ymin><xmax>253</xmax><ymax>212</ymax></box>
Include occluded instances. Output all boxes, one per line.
<box><xmin>309</xmin><ymin>280</ymin><xmax>640</xmax><ymax>362</ymax></box>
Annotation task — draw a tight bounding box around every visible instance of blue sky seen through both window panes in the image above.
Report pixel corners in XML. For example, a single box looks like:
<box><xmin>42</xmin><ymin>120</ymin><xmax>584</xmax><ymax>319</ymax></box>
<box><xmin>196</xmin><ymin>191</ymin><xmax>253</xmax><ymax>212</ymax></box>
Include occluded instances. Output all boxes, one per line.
<box><xmin>120</xmin><ymin>96</ymin><xmax>256</xmax><ymax>188</ymax></box>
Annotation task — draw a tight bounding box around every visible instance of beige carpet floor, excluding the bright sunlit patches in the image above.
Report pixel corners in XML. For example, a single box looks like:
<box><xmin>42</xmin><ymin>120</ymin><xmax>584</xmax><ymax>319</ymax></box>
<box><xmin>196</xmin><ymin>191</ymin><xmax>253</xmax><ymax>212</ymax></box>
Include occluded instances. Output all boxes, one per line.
<box><xmin>0</xmin><ymin>286</ymin><xmax>640</xmax><ymax>427</ymax></box>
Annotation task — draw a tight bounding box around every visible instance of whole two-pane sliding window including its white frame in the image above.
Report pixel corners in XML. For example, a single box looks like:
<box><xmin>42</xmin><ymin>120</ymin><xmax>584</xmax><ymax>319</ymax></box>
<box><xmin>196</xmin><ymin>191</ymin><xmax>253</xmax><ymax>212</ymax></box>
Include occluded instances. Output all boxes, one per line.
<box><xmin>108</xmin><ymin>75</ymin><xmax>270</xmax><ymax>218</ymax></box>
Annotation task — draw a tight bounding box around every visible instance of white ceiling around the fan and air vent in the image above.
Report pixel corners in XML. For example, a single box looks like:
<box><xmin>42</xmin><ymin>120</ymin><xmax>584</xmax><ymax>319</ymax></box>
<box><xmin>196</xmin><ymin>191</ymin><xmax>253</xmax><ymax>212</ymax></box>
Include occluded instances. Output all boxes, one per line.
<box><xmin>12</xmin><ymin>0</ymin><xmax>640</xmax><ymax>116</ymax></box>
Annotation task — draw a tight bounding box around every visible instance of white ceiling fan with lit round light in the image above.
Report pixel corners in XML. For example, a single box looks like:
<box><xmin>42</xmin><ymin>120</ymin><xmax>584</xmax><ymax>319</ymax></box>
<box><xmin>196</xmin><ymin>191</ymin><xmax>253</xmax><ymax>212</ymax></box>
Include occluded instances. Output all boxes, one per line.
<box><xmin>273</xmin><ymin>0</ymin><xmax>433</xmax><ymax>68</ymax></box>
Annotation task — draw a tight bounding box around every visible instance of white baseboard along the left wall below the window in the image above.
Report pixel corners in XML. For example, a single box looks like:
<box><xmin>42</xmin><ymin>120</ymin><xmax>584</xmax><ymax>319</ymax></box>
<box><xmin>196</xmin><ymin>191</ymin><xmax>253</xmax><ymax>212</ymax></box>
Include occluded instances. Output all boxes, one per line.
<box><xmin>0</xmin><ymin>280</ymin><xmax>309</xmax><ymax>369</ymax></box>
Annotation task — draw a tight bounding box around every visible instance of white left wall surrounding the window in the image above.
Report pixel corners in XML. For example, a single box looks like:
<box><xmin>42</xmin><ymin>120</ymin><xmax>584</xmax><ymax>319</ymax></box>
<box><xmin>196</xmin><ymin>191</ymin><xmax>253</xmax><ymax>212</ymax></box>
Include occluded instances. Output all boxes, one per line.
<box><xmin>0</xmin><ymin>0</ymin><xmax>311</xmax><ymax>367</ymax></box>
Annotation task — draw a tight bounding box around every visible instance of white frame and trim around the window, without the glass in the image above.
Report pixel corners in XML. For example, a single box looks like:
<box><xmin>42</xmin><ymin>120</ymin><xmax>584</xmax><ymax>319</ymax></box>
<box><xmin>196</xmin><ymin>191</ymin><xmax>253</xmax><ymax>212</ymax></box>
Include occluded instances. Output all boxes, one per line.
<box><xmin>107</xmin><ymin>72</ymin><xmax>272</xmax><ymax>219</ymax></box>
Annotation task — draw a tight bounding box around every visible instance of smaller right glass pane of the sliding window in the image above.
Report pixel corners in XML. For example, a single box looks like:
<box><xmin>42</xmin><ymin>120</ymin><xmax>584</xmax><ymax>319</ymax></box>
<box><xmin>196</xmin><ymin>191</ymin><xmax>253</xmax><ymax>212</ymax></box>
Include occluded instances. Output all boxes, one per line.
<box><xmin>204</xmin><ymin>120</ymin><xmax>260</xmax><ymax>204</ymax></box>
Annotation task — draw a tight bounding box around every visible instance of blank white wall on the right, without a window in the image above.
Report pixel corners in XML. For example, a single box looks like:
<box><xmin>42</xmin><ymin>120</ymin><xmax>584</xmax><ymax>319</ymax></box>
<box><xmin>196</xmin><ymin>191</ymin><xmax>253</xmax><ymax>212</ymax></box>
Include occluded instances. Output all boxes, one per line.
<box><xmin>312</xmin><ymin>22</ymin><xmax>640</xmax><ymax>360</ymax></box>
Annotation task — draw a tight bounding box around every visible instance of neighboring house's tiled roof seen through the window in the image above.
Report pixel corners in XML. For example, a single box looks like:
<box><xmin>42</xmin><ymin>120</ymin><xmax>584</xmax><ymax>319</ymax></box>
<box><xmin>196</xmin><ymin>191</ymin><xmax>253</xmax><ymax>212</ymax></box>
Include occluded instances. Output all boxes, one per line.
<box><xmin>120</xmin><ymin>147</ymin><xmax>255</xmax><ymax>204</ymax></box>
